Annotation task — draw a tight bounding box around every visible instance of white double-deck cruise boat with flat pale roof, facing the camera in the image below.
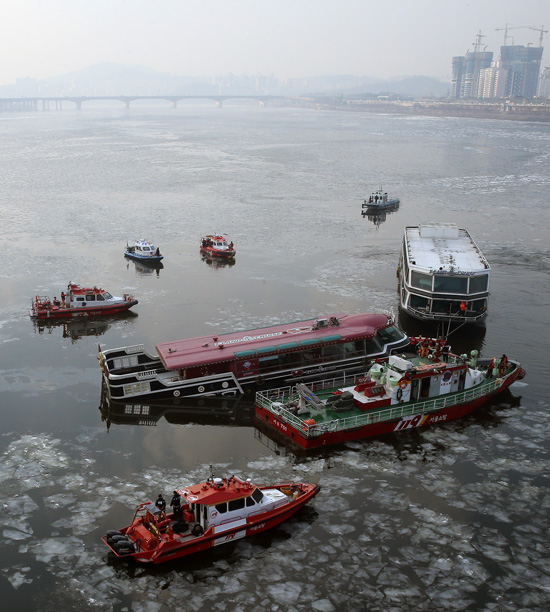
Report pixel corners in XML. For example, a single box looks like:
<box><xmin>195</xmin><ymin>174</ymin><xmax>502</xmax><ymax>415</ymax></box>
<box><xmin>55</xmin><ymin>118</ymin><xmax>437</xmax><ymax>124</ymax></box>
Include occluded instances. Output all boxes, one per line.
<box><xmin>397</xmin><ymin>223</ymin><xmax>491</xmax><ymax>323</ymax></box>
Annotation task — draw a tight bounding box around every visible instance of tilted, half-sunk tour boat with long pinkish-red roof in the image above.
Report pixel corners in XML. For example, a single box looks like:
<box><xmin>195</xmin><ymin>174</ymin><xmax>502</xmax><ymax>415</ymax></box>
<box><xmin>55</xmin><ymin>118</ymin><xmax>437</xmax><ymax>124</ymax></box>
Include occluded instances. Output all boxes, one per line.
<box><xmin>98</xmin><ymin>313</ymin><xmax>409</xmax><ymax>401</ymax></box>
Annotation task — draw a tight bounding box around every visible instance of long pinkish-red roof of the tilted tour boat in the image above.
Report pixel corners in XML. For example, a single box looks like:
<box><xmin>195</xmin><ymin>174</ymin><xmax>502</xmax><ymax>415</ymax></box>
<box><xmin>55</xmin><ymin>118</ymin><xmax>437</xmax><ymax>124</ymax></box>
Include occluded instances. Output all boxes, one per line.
<box><xmin>156</xmin><ymin>313</ymin><xmax>389</xmax><ymax>370</ymax></box>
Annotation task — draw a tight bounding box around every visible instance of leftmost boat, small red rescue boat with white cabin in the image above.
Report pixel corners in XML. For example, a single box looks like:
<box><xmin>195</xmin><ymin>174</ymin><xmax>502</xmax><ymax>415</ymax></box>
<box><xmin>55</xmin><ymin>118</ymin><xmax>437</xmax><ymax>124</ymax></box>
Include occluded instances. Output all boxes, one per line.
<box><xmin>30</xmin><ymin>283</ymin><xmax>138</xmax><ymax>319</ymax></box>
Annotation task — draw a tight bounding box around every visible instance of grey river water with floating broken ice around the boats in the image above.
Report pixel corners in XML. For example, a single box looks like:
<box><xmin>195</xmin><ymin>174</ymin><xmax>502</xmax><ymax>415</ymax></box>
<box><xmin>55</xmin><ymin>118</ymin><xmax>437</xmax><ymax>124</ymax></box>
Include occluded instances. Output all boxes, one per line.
<box><xmin>0</xmin><ymin>103</ymin><xmax>550</xmax><ymax>612</ymax></box>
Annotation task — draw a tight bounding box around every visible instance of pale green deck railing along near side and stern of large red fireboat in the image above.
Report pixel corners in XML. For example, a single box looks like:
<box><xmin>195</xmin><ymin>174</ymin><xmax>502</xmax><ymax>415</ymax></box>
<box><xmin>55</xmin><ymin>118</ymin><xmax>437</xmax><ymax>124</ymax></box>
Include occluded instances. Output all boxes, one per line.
<box><xmin>256</xmin><ymin>378</ymin><xmax>503</xmax><ymax>438</ymax></box>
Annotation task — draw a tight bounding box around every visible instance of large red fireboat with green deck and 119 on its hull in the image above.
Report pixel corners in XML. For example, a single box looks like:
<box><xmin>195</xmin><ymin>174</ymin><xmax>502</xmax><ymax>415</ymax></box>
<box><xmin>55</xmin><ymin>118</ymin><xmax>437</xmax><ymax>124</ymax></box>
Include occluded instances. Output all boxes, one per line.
<box><xmin>255</xmin><ymin>338</ymin><xmax>525</xmax><ymax>449</ymax></box>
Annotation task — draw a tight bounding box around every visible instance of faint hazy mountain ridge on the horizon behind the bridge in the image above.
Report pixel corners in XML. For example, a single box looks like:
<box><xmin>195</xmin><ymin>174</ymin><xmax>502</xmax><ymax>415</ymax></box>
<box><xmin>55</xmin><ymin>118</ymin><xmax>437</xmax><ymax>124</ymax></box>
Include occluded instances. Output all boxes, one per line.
<box><xmin>0</xmin><ymin>63</ymin><xmax>448</xmax><ymax>98</ymax></box>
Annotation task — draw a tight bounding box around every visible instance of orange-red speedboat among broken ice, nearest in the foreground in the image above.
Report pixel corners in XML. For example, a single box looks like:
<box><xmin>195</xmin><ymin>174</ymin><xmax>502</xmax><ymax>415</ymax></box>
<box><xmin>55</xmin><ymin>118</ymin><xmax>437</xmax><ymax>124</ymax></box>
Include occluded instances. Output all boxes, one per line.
<box><xmin>101</xmin><ymin>475</ymin><xmax>320</xmax><ymax>564</ymax></box>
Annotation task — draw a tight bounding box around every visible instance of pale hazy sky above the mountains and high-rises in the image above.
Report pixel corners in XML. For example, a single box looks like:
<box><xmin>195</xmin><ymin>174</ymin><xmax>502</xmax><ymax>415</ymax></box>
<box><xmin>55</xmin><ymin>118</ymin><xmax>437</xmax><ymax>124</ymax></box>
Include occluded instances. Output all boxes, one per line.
<box><xmin>0</xmin><ymin>0</ymin><xmax>550</xmax><ymax>85</ymax></box>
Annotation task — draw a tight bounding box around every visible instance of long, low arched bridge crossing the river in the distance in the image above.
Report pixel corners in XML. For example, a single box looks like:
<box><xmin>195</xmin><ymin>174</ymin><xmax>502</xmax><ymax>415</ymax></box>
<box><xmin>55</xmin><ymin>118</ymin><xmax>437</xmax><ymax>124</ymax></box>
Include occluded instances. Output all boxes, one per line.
<box><xmin>0</xmin><ymin>94</ymin><xmax>324</xmax><ymax>111</ymax></box>
